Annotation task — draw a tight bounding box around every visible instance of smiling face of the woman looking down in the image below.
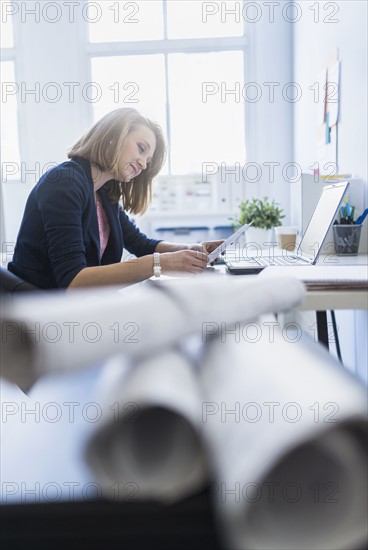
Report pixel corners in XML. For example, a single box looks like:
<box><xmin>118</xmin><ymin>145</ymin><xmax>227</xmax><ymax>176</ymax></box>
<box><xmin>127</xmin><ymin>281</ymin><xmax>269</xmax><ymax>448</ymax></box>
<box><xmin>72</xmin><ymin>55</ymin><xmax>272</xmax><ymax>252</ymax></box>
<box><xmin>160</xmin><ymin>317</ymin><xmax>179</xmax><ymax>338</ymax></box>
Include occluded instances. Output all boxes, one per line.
<box><xmin>116</xmin><ymin>125</ymin><xmax>156</xmax><ymax>183</ymax></box>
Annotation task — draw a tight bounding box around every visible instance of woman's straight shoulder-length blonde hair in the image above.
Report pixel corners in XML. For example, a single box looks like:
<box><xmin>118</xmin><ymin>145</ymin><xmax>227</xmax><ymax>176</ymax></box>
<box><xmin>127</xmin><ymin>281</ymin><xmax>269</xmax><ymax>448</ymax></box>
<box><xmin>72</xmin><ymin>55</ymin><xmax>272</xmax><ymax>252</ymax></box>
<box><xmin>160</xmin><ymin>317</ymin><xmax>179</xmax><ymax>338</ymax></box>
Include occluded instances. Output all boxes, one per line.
<box><xmin>67</xmin><ymin>108</ymin><xmax>166</xmax><ymax>214</ymax></box>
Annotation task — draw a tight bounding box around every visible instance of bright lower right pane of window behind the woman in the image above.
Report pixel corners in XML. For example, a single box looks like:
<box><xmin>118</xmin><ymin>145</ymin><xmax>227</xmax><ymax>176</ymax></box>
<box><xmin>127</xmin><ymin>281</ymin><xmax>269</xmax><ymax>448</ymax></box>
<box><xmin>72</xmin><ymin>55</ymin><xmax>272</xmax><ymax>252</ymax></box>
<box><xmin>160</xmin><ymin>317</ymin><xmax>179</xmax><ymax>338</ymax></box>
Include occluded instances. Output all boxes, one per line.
<box><xmin>168</xmin><ymin>51</ymin><xmax>245</xmax><ymax>174</ymax></box>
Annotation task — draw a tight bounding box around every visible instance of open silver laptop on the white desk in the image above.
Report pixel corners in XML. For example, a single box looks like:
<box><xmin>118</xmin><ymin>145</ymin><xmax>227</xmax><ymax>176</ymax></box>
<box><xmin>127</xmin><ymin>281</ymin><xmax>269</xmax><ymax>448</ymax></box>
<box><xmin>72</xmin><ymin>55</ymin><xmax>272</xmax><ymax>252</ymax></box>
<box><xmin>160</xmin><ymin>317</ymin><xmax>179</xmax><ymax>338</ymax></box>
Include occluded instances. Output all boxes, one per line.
<box><xmin>225</xmin><ymin>182</ymin><xmax>349</xmax><ymax>275</ymax></box>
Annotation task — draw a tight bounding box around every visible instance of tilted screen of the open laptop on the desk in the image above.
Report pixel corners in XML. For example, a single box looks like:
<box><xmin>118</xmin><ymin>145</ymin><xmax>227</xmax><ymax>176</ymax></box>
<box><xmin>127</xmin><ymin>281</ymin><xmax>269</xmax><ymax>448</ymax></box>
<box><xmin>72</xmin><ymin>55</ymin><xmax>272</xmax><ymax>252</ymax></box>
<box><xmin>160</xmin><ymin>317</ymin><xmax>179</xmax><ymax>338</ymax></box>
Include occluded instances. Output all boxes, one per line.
<box><xmin>298</xmin><ymin>182</ymin><xmax>349</xmax><ymax>261</ymax></box>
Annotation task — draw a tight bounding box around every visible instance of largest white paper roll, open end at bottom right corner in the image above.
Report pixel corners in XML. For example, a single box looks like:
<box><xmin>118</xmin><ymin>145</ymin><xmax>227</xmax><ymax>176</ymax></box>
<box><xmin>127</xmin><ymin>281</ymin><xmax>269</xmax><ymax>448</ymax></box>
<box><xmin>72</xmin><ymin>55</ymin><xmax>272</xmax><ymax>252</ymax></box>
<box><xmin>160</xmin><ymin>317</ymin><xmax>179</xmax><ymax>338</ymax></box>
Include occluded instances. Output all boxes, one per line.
<box><xmin>199</xmin><ymin>318</ymin><xmax>368</xmax><ymax>550</ymax></box>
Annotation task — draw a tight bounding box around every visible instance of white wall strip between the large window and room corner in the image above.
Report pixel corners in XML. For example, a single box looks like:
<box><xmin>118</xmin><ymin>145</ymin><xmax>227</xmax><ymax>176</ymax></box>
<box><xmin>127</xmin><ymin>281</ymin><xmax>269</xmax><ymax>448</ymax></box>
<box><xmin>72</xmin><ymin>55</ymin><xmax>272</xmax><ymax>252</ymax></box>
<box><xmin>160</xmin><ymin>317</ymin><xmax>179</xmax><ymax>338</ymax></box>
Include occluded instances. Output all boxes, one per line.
<box><xmin>245</xmin><ymin>13</ymin><xmax>293</xmax><ymax>223</ymax></box>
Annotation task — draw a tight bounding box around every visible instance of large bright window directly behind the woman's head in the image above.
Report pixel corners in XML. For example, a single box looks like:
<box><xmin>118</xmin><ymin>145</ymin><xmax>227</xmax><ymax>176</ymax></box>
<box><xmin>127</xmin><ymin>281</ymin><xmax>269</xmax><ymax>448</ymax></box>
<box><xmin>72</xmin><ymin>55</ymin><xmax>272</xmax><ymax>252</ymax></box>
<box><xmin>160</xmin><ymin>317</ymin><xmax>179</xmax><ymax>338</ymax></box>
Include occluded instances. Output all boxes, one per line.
<box><xmin>87</xmin><ymin>0</ymin><xmax>245</xmax><ymax>174</ymax></box>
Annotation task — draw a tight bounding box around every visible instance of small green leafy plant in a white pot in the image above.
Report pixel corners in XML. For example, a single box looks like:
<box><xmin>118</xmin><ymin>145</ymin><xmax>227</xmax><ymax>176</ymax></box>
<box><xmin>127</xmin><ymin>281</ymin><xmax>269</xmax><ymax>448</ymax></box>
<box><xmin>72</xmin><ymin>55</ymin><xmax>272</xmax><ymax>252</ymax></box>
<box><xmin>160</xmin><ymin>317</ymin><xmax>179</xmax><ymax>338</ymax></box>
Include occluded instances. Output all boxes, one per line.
<box><xmin>231</xmin><ymin>197</ymin><xmax>285</xmax><ymax>248</ymax></box>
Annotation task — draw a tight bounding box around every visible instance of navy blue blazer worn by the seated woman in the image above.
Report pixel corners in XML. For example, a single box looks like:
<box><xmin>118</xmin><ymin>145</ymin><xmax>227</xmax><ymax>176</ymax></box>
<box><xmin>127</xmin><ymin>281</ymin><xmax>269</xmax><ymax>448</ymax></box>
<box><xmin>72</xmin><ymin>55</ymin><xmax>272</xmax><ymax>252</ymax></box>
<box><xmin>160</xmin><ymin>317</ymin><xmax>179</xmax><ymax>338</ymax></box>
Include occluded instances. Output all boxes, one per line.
<box><xmin>8</xmin><ymin>158</ymin><xmax>159</xmax><ymax>289</ymax></box>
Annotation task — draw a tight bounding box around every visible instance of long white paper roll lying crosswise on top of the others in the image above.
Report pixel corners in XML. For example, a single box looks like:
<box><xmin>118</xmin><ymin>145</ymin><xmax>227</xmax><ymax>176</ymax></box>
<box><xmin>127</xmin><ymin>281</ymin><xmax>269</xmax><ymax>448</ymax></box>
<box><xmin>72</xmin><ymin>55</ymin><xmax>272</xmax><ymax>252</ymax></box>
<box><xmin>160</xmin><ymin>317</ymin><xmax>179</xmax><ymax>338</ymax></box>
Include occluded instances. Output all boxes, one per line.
<box><xmin>1</xmin><ymin>275</ymin><xmax>304</xmax><ymax>387</ymax></box>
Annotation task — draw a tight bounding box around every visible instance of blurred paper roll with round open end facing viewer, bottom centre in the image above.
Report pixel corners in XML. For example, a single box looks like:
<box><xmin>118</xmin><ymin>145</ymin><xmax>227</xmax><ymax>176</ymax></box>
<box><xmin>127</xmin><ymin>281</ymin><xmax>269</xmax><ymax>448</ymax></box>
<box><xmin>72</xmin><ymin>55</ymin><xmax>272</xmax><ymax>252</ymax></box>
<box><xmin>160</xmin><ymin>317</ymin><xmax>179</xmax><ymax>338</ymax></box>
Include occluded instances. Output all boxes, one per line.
<box><xmin>86</xmin><ymin>349</ymin><xmax>207</xmax><ymax>502</ymax></box>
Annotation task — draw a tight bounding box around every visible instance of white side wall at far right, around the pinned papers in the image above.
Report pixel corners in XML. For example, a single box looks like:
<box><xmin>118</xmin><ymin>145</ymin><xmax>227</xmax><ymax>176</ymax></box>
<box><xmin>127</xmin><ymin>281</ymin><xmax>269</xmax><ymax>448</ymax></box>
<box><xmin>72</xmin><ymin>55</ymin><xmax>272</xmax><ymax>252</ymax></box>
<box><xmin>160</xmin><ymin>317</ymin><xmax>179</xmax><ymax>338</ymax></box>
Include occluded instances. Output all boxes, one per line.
<box><xmin>294</xmin><ymin>0</ymin><xmax>368</xmax><ymax>380</ymax></box>
